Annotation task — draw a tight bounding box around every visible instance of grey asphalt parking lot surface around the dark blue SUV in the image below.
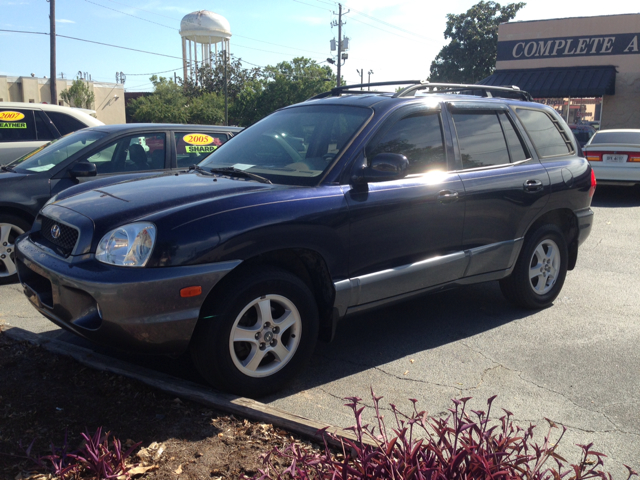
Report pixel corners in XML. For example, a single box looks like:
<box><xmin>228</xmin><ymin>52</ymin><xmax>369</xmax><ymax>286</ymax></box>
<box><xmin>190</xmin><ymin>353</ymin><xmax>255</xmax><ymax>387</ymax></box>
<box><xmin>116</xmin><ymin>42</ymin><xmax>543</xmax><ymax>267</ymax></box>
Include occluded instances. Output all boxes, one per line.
<box><xmin>0</xmin><ymin>186</ymin><xmax>640</xmax><ymax>478</ymax></box>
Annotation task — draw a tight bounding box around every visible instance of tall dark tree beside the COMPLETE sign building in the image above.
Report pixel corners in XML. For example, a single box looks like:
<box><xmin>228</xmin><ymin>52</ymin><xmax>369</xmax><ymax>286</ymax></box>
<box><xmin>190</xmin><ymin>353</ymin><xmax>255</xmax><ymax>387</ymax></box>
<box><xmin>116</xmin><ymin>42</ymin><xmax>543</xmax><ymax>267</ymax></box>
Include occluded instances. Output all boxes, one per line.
<box><xmin>429</xmin><ymin>0</ymin><xmax>526</xmax><ymax>83</ymax></box>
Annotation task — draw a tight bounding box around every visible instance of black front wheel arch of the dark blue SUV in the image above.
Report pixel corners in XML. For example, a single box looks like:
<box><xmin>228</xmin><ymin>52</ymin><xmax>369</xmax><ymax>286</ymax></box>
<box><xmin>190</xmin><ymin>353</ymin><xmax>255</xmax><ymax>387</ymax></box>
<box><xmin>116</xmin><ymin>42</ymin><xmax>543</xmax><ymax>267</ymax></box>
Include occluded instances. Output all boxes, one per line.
<box><xmin>200</xmin><ymin>248</ymin><xmax>338</xmax><ymax>341</ymax></box>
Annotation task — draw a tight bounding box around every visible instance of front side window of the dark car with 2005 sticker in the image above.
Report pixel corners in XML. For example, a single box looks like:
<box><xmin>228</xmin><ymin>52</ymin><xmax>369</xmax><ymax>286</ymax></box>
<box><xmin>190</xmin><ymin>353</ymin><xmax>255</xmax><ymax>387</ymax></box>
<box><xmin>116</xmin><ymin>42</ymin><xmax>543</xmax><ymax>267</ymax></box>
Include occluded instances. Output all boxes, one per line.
<box><xmin>83</xmin><ymin>133</ymin><xmax>165</xmax><ymax>174</ymax></box>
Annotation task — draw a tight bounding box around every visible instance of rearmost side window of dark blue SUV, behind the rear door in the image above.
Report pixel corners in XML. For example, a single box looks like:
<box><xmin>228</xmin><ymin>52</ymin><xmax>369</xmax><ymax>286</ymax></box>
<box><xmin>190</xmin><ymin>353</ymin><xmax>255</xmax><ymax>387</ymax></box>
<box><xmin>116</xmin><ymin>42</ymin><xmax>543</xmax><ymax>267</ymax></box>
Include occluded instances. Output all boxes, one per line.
<box><xmin>516</xmin><ymin>108</ymin><xmax>572</xmax><ymax>157</ymax></box>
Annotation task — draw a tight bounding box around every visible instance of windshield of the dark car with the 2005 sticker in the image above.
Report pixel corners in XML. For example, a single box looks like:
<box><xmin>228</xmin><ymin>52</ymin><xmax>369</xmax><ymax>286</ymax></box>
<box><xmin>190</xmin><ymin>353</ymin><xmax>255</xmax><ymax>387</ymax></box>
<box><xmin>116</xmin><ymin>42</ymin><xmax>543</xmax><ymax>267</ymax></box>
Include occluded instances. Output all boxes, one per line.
<box><xmin>11</xmin><ymin>131</ymin><xmax>107</xmax><ymax>173</ymax></box>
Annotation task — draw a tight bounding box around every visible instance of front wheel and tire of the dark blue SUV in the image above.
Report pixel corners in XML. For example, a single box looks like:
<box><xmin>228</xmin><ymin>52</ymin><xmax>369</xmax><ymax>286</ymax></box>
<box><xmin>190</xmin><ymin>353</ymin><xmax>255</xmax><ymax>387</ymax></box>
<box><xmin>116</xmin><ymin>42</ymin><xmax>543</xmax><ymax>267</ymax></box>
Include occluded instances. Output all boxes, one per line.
<box><xmin>191</xmin><ymin>267</ymin><xmax>319</xmax><ymax>397</ymax></box>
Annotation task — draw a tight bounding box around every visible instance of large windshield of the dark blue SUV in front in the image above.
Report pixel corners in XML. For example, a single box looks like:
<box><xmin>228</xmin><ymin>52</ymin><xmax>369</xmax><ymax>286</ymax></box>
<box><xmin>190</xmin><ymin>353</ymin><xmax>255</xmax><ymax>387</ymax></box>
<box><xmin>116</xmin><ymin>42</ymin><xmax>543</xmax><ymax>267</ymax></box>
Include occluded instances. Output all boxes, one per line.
<box><xmin>200</xmin><ymin>105</ymin><xmax>372</xmax><ymax>185</ymax></box>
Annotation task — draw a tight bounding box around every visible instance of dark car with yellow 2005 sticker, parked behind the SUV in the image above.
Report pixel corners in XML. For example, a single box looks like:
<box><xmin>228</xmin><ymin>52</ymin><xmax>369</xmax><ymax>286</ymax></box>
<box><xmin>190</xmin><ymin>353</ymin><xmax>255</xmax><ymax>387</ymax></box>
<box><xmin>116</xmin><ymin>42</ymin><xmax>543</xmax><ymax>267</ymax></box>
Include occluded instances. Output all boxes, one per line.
<box><xmin>0</xmin><ymin>123</ymin><xmax>242</xmax><ymax>284</ymax></box>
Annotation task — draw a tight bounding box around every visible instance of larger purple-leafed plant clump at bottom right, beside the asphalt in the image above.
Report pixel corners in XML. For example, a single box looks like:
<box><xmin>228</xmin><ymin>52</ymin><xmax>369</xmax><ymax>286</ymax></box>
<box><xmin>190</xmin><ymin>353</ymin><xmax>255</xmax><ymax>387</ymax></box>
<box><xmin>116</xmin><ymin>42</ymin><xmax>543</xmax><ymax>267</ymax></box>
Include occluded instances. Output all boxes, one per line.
<box><xmin>248</xmin><ymin>391</ymin><xmax>637</xmax><ymax>480</ymax></box>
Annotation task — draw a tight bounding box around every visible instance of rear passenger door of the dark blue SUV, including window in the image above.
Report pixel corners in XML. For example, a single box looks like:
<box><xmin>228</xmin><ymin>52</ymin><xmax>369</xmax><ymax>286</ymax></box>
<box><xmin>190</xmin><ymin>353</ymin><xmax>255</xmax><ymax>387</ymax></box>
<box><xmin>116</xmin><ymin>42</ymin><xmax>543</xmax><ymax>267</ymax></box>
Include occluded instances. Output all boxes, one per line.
<box><xmin>447</xmin><ymin>102</ymin><xmax>550</xmax><ymax>276</ymax></box>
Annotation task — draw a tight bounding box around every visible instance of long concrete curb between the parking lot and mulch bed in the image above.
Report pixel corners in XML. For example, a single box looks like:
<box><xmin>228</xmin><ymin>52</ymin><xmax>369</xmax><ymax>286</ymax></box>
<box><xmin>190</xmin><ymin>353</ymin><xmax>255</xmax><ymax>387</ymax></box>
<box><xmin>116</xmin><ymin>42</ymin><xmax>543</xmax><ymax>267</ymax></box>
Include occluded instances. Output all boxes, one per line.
<box><xmin>0</xmin><ymin>327</ymin><xmax>374</xmax><ymax>445</ymax></box>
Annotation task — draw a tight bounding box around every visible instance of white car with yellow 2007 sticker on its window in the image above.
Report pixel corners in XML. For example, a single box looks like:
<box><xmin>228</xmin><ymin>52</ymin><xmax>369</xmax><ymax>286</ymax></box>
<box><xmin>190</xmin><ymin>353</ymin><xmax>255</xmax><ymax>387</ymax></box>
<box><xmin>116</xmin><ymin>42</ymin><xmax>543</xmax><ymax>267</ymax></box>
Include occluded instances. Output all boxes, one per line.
<box><xmin>0</xmin><ymin>102</ymin><xmax>104</xmax><ymax>165</ymax></box>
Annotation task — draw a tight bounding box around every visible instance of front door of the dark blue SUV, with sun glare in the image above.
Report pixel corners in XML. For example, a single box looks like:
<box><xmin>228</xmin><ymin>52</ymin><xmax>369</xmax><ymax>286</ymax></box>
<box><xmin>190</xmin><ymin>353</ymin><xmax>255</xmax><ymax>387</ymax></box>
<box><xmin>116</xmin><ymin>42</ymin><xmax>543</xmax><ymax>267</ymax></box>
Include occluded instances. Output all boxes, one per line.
<box><xmin>345</xmin><ymin>105</ymin><xmax>465</xmax><ymax>305</ymax></box>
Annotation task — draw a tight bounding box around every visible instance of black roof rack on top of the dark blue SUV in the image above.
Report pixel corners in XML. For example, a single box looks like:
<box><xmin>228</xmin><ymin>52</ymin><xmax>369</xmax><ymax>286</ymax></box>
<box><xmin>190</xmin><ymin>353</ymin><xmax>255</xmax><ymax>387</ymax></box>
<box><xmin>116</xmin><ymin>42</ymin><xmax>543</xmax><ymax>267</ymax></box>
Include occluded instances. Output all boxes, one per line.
<box><xmin>309</xmin><ymin>80</ymin><xmax>533</xmax><ymax>102</ymax></box>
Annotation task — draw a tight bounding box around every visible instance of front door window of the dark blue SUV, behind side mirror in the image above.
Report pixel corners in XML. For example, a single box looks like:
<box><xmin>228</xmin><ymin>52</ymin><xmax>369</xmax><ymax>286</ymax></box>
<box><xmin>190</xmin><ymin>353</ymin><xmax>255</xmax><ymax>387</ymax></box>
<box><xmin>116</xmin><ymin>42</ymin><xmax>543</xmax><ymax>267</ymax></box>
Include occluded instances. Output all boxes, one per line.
<box><xmin>365</xmin><ymin>112</ymin><xmax>447</xmax><ymax>174</ymax></box>
